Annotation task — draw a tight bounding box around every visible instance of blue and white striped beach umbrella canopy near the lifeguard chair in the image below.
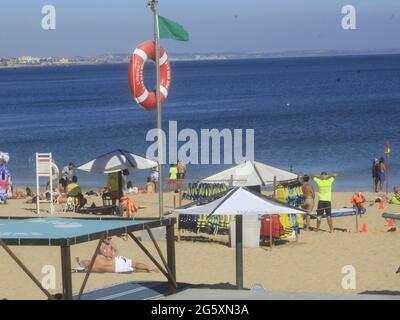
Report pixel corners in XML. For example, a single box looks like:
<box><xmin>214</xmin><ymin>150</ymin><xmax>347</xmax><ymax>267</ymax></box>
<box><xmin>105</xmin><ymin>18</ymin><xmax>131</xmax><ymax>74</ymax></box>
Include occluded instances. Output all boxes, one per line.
<box><xmin>77</xmin><ymin>149</ymin><xmax>158</xmax><ymax>173</ymax></box>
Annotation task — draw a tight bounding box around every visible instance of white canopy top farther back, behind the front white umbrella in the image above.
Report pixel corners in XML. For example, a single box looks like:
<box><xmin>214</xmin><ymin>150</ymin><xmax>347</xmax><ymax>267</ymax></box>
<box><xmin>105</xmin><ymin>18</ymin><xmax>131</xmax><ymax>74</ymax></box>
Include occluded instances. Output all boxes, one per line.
<box><xmin>202</xmin><ymin>160</ymin><xmax>297</xmax><ymax>187</ymax></box>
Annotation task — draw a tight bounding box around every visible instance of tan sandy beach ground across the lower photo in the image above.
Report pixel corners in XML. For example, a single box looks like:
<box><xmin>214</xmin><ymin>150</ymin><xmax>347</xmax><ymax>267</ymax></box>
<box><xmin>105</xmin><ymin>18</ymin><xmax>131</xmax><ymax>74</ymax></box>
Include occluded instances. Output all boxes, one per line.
<box><xmin>0</xmin><ymin>192</ymin><xmax>400</xmax><ymax>299</ymax></box>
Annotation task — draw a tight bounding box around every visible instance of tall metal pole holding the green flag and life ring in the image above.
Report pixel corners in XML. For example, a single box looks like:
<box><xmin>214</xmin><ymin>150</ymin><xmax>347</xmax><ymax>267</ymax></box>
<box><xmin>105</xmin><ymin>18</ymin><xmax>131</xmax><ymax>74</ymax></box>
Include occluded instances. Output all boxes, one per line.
<box><xmin>148</xmin><ymin>0</ymin><xmax>164</xmax><ymax>219</ymax></box>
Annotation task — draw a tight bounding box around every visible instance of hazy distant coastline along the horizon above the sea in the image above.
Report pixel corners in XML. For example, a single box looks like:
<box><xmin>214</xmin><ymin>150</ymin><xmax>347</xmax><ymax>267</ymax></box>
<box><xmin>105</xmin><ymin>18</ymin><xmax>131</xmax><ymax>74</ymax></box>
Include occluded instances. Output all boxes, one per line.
<box><xmin>0</xmin><ymin>49</ymin><xmax>400</xmax><ymax>68</ymax></box>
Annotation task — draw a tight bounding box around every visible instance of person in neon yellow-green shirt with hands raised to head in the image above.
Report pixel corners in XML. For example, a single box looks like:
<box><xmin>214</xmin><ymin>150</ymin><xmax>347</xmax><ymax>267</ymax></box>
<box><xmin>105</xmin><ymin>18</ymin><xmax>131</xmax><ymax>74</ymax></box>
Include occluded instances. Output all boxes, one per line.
<box><xmin>313</xmin><ymin>172</ymin><xmax>336</xmax><ymax>232</ymax></box>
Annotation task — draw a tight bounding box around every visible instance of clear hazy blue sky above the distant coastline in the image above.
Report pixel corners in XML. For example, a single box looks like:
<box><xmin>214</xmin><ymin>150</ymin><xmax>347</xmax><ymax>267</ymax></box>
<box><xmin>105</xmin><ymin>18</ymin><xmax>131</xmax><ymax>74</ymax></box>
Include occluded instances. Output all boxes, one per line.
<box><xmin>0</xmin><ymin>0</ymin><xmax>400</xmax><ymax>57</ymax></box>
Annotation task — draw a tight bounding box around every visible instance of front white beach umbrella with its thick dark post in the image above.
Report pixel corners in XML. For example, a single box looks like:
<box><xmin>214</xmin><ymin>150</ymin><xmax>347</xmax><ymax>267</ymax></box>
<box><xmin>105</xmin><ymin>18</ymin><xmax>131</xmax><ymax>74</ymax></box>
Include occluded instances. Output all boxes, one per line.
<box><xmin>170</xmin><ymin>187</ymin><xmax>307</xmax><ymax>289</ymax></box>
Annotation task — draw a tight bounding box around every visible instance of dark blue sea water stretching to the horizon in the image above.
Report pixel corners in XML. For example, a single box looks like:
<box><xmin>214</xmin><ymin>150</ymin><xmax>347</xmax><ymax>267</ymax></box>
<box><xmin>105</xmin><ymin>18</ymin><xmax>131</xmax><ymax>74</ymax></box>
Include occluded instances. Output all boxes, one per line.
<box><xmin>0</xmin><ymin>55</ymin><xmax>400</xmax><ymax>190</ymax></box>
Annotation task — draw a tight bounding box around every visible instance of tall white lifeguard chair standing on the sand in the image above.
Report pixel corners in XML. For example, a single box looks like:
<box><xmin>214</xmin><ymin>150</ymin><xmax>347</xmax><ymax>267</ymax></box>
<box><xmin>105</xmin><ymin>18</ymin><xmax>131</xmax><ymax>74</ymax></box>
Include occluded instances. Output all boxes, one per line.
<box><xmin>36</xmin><ymin>153</ymin><xmax>55</xmax><ymax>214</ymax></box>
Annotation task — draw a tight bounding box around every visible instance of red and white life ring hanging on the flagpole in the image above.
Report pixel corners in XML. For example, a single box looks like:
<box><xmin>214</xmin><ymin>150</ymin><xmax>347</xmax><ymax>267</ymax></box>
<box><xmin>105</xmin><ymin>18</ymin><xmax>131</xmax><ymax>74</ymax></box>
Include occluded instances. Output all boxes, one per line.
<box><xmin>129</xmin><ymin>41</ymin><xmax>171</xmax><ymax>110</ymax></box>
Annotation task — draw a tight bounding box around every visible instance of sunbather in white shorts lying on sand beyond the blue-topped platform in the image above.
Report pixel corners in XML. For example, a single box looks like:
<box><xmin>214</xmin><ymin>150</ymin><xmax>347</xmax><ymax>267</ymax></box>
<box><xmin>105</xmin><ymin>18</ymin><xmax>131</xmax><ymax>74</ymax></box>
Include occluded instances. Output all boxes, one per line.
<box><xmin>76</xmin><ymin>237</ymin><xmax>158</xmax><ymax>273</ymax></box>
